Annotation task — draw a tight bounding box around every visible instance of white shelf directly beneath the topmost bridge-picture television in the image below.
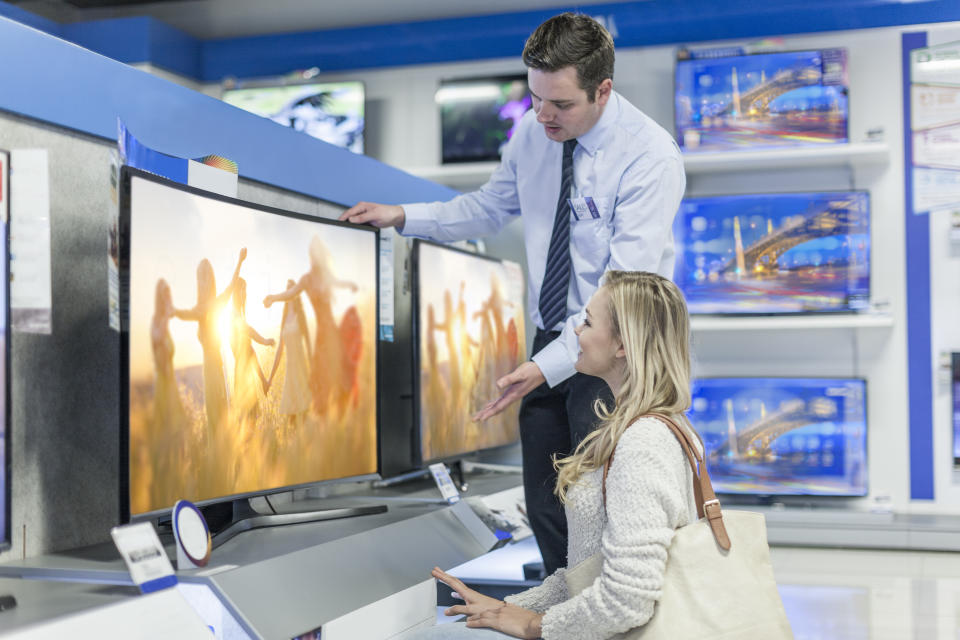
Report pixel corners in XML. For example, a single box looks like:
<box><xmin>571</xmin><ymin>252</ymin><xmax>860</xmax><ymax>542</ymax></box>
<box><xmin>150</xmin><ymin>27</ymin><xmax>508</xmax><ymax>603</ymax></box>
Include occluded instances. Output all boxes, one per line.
<box><xmin>683</xmin><ymin>142</ymin><xmax>890</xmax><ymax>175</ymax></box>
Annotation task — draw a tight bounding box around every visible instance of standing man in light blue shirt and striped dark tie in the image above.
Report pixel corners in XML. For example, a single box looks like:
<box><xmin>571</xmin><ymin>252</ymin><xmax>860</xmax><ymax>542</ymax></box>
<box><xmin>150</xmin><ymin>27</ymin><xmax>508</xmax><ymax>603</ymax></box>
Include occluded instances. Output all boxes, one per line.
<box><xmin>340</xmin><ymin>13</ymin><xmax>685</xmax><ymax>574</ymax></box>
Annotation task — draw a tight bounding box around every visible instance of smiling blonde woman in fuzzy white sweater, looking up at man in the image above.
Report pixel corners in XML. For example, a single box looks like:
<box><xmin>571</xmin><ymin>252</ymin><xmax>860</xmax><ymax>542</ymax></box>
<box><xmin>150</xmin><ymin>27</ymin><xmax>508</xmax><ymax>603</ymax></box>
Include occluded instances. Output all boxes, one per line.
<box><xmin>416</xmin><ymin>271</ymin><xmax>697</xmax><ymax>640</ymax></box>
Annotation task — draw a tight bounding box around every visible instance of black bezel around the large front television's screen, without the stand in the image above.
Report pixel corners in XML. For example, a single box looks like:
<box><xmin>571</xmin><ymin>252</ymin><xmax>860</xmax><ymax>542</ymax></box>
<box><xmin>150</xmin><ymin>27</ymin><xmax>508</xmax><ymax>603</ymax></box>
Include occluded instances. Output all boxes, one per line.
<box><xmin>118</xmin><ymin>165</ymin><xmax>381</xmax><ymax>523</ymax></box>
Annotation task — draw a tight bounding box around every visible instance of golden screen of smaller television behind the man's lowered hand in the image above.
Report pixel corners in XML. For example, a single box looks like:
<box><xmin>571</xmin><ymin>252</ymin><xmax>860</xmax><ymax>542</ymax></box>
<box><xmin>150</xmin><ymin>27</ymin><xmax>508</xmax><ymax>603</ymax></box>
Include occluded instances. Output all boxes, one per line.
<box><xmin>414</xmin><ymin>241</ymin><xmax>526</xmax><ymax>461</ymax></box>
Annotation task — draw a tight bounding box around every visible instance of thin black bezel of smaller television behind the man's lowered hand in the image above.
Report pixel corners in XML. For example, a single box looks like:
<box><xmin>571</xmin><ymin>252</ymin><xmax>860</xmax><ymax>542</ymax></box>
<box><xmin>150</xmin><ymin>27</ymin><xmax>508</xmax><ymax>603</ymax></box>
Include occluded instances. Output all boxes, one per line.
<box><xmin>410</xmin><ymin>238</ymin><xmax>527</xmax><ymax>469</ymax></box>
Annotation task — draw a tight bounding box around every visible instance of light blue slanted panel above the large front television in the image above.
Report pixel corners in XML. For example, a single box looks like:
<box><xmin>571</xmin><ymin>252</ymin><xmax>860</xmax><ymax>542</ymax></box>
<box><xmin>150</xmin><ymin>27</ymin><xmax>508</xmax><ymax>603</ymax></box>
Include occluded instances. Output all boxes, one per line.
<box><xmin>0</xmin><ymin>18</ymin><xmax>457</xmax><ymax>205</ymax></box>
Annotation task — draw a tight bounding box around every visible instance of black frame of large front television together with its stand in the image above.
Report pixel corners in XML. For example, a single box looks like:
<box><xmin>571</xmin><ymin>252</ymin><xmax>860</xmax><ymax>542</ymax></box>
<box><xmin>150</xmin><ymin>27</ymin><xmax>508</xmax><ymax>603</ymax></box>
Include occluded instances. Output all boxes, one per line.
<box><xmin>118</xmin><ymin>166</ymin><xmax>386</xmax><ymax>536</ymax></box>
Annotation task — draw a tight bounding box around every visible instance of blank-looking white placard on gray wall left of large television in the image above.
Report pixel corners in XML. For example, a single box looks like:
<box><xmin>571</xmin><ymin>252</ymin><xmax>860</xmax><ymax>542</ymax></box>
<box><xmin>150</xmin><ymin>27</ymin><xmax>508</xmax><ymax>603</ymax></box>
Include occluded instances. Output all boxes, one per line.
<box><xmin>10</xmin><ymin>149</ymin><xmax>52</xmax><ymax>334</ymax></box>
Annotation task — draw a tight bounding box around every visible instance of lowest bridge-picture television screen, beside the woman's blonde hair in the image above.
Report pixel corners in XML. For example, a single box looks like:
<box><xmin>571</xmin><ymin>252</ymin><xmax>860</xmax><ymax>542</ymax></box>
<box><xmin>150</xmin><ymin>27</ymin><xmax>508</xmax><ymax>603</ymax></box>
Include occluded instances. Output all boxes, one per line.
<box><xmin>689</xmin><ymin>378</ymin><xmax>867</xmax><ymax>496</ymax></box>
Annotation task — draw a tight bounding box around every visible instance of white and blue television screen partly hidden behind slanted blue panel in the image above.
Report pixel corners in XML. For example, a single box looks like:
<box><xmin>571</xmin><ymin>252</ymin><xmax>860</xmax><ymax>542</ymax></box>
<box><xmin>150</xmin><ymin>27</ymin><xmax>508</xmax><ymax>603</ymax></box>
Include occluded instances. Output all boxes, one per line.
<box><xmin>223</xmin><ymin>82</ymin><xmax>364</xmax><ymax>153</ymax></box>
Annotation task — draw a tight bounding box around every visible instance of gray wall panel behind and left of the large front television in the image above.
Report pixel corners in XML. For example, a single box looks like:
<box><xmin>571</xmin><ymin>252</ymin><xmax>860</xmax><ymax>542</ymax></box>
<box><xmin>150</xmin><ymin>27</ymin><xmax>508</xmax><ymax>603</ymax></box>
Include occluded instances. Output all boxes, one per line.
<box><xmin>0</xmin><ymin>112</ymin><xmax>356</xmax><ymax>561</ymax></box>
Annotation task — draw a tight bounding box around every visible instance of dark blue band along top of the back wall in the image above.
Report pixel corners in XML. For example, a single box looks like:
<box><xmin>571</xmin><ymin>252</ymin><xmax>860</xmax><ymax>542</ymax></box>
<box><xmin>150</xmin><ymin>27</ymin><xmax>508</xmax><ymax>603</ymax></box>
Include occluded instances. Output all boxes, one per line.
<box><xmin>0</xmin><ymin>0</ymin><xmax>960</xmax><ymax>82</ymax></box>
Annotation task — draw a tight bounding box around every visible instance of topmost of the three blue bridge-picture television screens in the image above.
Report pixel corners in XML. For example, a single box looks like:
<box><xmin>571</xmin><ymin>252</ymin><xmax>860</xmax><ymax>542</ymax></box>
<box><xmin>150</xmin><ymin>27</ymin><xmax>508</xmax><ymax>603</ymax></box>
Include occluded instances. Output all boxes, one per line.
<box><xmin>674</xmin><ymin>49</ymin><xmax>847</xmax><ymax>151</ymax></box>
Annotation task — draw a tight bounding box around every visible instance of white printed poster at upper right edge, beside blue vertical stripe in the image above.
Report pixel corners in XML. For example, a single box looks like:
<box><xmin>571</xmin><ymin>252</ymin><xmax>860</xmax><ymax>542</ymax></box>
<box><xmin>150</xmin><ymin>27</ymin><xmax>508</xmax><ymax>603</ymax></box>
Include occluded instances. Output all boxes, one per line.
<box><xmin>910</xmin><ymin>41</ymin><xmax>960</xmax><ymax>214</ymax></box>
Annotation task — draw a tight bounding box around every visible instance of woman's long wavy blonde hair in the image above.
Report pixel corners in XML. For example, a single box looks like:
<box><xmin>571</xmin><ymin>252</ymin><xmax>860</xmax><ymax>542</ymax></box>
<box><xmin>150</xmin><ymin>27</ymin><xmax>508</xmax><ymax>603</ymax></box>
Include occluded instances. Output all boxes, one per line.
<box><xmin>554</xmin><ymin>271</ymin><xmax>690</xmax><ymax>503</ymax></box>
